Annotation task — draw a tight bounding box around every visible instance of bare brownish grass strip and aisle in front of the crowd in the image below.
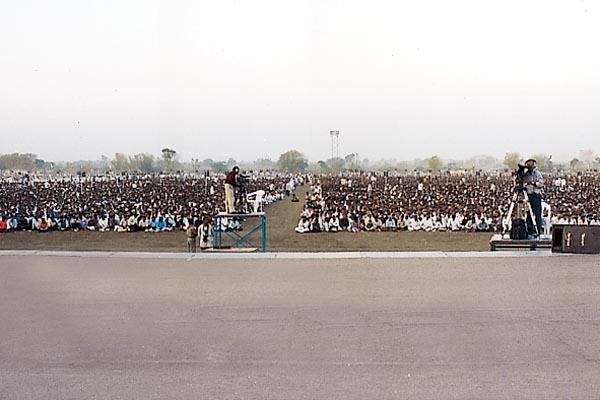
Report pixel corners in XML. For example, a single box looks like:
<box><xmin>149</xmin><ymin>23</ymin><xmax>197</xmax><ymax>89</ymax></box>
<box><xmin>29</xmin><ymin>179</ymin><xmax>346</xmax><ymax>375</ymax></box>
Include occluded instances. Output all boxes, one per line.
<box><xmin>0</xmin><ymin>194</ymin><xmax>491</xmax><ymax>252</ymax></box>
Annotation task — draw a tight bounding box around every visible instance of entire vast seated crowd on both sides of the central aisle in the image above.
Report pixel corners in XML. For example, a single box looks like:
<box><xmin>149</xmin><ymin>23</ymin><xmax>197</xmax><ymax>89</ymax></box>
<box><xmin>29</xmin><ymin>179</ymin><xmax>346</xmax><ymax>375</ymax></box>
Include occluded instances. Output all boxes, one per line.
<box><xmin>0</xmin><ymin>167</ymin><xmax>600</xmax><ymax>234</ymax></box>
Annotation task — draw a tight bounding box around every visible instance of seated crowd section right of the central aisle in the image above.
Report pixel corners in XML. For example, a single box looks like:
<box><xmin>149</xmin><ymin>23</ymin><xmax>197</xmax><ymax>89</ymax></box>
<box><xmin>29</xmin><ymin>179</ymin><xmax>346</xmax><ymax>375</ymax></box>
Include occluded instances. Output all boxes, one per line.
<box><xmin>295</xmin><ymin>172</ymin><xmax>600</xmax><ymax>234</ymax></box>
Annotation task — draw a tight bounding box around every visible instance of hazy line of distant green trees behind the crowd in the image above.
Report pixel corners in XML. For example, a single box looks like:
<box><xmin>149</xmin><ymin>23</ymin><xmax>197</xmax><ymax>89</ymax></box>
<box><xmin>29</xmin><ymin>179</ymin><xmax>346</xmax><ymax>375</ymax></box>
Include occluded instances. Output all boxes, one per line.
<box><xmin>0</xmin><ymin>148</ymin><xmax>600</xmax><ymax>174</ymax></box>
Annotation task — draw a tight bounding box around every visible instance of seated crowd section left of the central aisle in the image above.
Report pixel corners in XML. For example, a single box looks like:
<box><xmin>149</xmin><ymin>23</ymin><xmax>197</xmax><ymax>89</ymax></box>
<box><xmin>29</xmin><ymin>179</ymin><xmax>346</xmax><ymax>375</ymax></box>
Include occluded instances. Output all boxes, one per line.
<box><xmin>0</xmin><ymin>172</ymin><xmax>293</xmax><ymax>232</ymax></box>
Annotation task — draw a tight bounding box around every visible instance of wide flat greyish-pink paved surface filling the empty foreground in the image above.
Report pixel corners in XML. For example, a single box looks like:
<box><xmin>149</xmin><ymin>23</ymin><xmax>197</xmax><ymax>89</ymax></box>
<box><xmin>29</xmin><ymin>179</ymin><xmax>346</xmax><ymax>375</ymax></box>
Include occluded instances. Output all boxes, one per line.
<box><xmin>0</xmin><ymin>256</ymin><xmax>600</xmax><ymax>400</ymax></box>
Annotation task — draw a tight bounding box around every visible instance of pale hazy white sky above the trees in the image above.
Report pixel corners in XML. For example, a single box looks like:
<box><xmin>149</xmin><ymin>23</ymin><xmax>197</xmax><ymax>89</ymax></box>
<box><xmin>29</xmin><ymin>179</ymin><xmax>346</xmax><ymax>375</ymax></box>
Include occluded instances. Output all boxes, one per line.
<box><xmin>0</xmin><ymin>0</ymin><xmax>600</xmax><ymax>160</ymax></box>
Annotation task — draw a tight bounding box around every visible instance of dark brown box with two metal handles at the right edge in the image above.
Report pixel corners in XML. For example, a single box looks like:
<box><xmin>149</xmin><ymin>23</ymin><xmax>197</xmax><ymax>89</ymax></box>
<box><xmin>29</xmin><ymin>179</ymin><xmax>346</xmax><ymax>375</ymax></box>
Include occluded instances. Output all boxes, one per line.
<box><xmin>552</xmin><ymin>225</ymin><xmax>600</xmax><ymax>254</ymax></box>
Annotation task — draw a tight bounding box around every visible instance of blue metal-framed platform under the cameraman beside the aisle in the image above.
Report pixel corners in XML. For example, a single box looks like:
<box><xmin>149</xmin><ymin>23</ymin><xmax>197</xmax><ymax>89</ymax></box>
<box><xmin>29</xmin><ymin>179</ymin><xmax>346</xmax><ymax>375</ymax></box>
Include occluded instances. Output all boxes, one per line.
<box><xmin>213</xmin><ymin>212</ymin><xmax>267</xmax><ymax>253</ymax></box>
